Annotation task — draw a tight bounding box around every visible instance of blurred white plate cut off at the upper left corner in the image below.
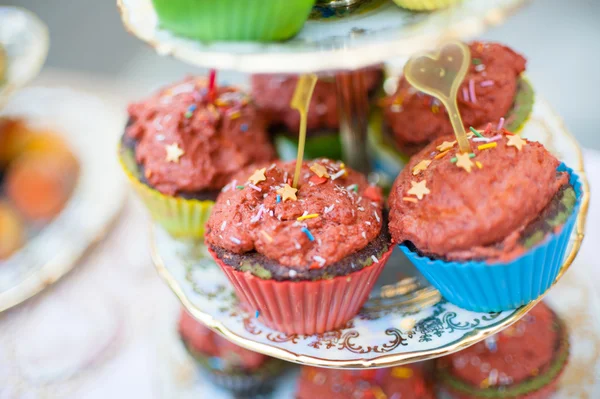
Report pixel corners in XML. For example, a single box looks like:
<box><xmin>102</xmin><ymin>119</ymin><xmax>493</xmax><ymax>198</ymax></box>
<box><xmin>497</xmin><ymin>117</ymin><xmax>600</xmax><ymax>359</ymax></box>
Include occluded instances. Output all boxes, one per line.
<box><xmin>0</xmin><ymin>6</ymin><xmax>49</xmax><ymax>108</ymax></box>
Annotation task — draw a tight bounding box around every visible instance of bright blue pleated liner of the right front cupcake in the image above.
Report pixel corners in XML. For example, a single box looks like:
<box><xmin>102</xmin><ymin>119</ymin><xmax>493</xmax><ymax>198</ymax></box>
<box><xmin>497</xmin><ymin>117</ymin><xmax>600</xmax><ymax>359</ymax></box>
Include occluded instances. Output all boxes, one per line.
<box><xmin>399</xmin><ymin>164</ymin><xmax>583</xmax><ymax>312</ymax></box>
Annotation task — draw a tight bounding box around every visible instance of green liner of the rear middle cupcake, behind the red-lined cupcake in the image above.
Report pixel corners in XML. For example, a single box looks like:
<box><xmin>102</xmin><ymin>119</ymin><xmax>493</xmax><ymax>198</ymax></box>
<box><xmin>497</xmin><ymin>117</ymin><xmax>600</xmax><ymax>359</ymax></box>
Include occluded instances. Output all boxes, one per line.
<box><xmin>273</xmin><ymin>131</ymin><xmax>342</xmax><ymax>161</ymax></box>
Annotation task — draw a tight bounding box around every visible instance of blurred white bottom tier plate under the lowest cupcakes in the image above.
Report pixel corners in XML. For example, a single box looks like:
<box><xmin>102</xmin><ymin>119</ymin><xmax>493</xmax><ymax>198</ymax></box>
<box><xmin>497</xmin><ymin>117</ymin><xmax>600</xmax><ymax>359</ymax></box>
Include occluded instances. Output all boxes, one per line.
<box><xmin>156</xmin><ymin>260</ymin><xmax>600</xmax><ymax>399</ymax></box>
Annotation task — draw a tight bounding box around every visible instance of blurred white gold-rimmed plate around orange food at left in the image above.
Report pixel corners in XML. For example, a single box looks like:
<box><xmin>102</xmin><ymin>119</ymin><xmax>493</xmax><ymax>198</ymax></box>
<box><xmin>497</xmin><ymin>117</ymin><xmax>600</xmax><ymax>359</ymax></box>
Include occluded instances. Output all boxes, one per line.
<box><xmin>0</xmin><ymin>87</ymin><xmax>127</xmax><ymax>312</ymax></box>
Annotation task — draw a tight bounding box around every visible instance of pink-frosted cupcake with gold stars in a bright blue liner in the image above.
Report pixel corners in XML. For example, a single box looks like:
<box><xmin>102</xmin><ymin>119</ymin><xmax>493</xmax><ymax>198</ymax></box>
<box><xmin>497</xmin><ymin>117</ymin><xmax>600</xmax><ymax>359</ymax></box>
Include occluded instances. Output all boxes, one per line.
<box><xmin>389</xmin><ymin>125</ymin><xmax>582</xmax><ymax>312</ymax></box>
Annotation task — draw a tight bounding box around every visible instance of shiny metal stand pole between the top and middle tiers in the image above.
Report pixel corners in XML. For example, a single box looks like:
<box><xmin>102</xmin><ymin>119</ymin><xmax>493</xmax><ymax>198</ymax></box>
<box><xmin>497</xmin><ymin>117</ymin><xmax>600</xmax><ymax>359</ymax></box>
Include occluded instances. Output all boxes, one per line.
<box><xmin>336</xmin><ymin>71</ymin><xmax>370</xmax><ymax>174</ymax></box>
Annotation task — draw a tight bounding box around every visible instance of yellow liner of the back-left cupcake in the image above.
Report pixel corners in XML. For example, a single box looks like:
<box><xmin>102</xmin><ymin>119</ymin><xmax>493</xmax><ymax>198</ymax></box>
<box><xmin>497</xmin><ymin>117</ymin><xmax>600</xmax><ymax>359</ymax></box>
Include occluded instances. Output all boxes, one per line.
<box><xmin>119</xmin><ymin>145</ymin><xmax>214</xmax><ymax>239</ymax></box>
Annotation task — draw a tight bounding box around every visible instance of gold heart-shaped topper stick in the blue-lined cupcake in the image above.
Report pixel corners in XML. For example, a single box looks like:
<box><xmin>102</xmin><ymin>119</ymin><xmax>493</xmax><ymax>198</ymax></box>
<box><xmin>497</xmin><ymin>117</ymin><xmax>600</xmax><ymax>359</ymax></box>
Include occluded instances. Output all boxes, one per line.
<box><xmin>404</xmin><ymin>42</ymin><xmax>471</xmax><ymax>153</ymax></box>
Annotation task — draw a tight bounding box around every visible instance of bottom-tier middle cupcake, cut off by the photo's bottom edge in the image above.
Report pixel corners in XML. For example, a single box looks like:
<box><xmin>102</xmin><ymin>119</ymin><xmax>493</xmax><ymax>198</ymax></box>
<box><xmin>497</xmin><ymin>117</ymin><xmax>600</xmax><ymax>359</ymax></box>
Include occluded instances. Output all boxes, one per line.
<box><xmin>296</xmin><ymin>364</ymin><xmax>435</xmax><ymax>399</ymax></box>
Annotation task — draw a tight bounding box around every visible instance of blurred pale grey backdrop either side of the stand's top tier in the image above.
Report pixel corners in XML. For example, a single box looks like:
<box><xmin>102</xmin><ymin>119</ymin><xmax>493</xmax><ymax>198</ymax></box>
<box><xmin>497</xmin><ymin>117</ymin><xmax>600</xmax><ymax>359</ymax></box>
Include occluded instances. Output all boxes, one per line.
<box><xmin>3</xmin><ymin>0</ymin><xmax>600</xmax><ymax>149</ymax></box>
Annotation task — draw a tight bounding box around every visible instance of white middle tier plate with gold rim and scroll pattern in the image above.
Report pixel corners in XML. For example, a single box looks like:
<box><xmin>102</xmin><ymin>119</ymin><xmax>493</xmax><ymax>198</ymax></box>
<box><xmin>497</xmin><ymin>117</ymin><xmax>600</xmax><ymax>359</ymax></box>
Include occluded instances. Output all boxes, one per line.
<box><xmin>152</xmin><ymin>99</ymin><xmax>589</xmax><ymax>368</ymax></box>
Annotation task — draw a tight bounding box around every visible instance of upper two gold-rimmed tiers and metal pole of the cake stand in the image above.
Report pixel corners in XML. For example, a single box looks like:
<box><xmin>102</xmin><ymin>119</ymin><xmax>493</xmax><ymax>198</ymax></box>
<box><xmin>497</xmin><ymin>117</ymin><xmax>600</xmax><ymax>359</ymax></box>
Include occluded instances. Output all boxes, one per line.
<box><xmin>118</xmin><ymin>0</ymin><xmax>589</xmax><ymax>368</ymax></box>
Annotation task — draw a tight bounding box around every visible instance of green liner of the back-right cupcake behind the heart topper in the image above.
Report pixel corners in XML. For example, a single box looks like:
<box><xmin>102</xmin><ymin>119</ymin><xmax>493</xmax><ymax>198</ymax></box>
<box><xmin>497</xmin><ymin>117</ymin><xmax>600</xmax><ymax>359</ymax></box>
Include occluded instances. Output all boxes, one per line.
<box><xmin>368</xmin><ymin>76</ymin><xmax>535</xmax><ymax>188</ymax></box>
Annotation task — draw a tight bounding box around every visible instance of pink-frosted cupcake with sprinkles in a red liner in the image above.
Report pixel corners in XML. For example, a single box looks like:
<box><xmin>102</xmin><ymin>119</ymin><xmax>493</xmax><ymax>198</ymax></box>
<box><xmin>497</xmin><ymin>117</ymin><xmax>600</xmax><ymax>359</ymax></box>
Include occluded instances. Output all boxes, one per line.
<box><xmin>206</xmin><ymin>159</ymin><xmax>392</xmax><ymax>334</ymax></box>
